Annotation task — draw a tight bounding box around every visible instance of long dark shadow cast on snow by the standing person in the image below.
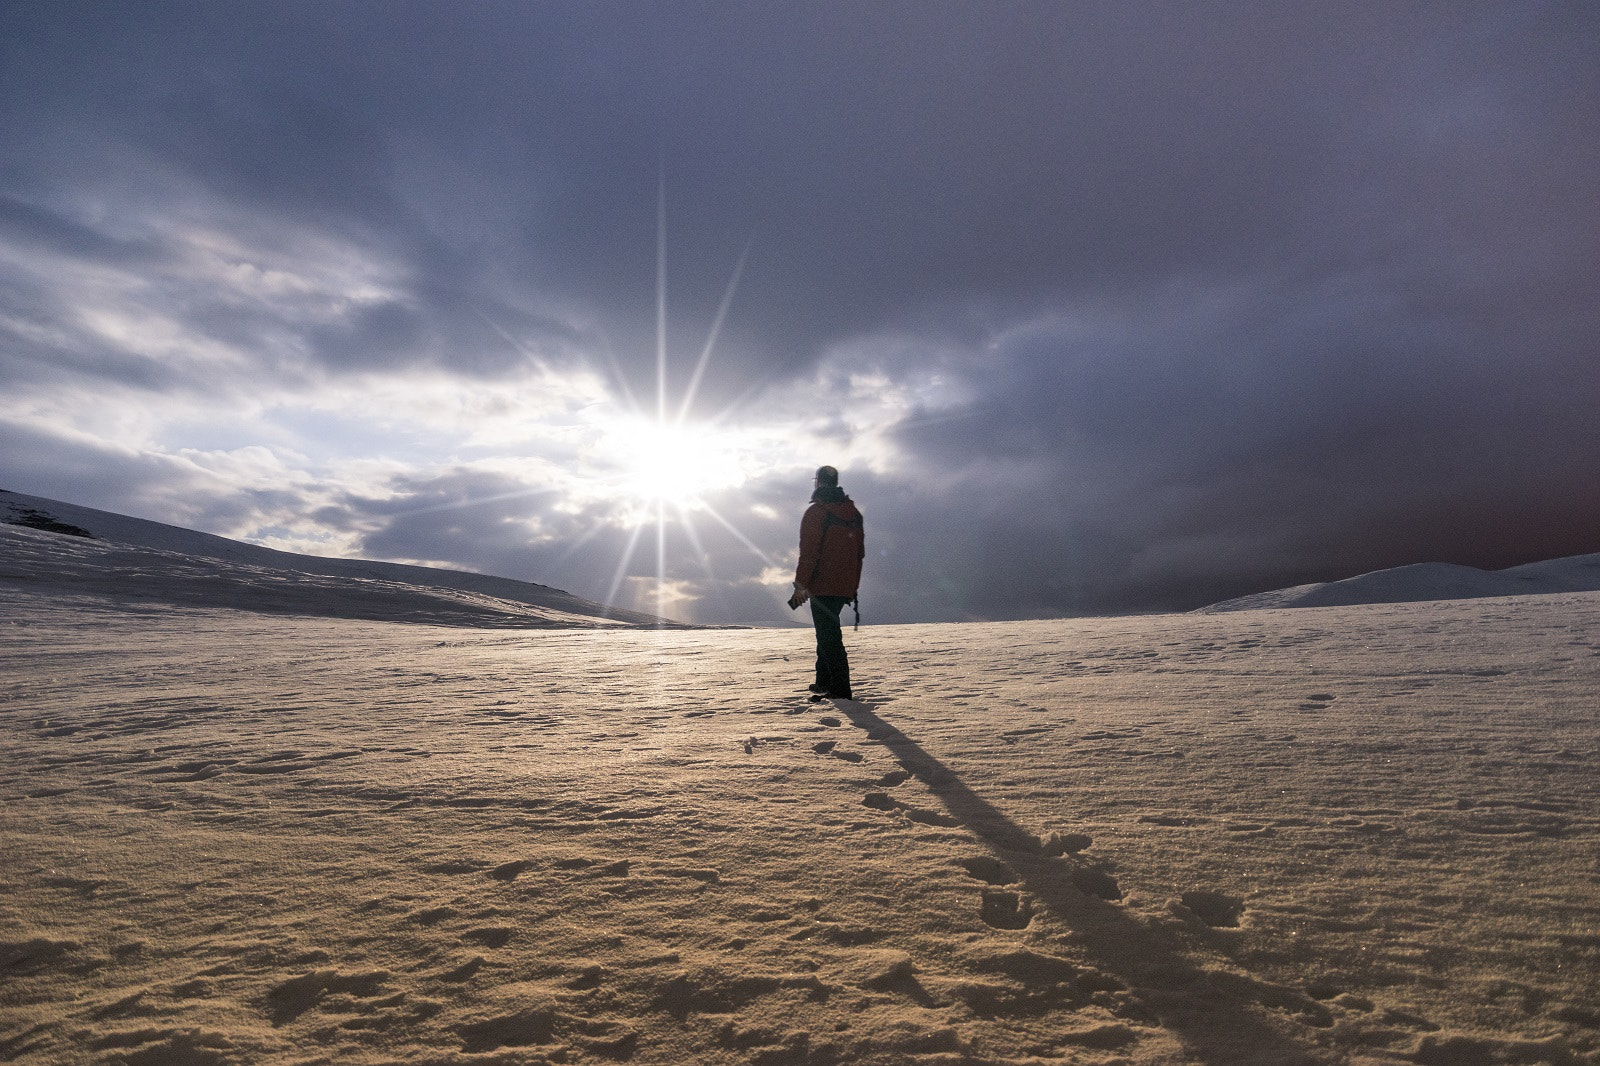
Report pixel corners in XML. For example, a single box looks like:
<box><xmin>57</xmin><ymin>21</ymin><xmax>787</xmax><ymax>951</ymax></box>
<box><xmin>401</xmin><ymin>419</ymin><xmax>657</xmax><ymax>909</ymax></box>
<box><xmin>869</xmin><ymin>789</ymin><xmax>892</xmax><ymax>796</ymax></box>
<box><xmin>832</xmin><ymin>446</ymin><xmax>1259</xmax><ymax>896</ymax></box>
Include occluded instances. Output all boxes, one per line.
<box><xmin>834</xmin><ymin>699</ymin><xmax>1333</xmax><ymax>1066</ymax></box>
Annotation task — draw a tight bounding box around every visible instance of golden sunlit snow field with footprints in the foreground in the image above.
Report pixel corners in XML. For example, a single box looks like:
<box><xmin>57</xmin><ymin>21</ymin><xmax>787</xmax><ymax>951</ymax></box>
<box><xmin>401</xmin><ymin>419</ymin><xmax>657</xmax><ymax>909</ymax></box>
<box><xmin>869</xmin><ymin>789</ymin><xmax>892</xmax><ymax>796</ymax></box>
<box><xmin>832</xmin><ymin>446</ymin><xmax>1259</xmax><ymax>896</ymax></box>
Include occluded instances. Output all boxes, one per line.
<box><xmin>0</xmin><ymin>582</ymin><xmax>1600</xmax><ymax>1066</ymax></box>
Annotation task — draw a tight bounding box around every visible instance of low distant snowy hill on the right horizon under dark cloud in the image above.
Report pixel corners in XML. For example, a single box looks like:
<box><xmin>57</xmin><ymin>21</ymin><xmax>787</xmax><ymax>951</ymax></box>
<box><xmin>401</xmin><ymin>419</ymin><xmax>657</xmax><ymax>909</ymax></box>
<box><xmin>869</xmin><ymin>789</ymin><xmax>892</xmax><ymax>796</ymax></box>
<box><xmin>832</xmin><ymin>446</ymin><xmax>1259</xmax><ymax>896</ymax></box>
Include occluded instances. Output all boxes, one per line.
<box><xmin>1197</xmin><ymin>554</ymin><xmax>1600</xmax><ymax>615</ymax></box>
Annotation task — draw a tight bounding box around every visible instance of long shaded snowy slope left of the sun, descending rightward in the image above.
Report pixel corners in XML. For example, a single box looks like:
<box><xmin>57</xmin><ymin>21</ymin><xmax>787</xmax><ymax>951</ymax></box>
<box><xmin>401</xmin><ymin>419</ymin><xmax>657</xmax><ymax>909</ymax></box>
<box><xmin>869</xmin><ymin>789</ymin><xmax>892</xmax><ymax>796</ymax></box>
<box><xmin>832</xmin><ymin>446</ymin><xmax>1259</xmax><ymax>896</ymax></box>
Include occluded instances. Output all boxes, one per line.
<box><xmin>0</xmin><ymin>490</ymin><xmax>680</xmax><ymax>627</ymax></box>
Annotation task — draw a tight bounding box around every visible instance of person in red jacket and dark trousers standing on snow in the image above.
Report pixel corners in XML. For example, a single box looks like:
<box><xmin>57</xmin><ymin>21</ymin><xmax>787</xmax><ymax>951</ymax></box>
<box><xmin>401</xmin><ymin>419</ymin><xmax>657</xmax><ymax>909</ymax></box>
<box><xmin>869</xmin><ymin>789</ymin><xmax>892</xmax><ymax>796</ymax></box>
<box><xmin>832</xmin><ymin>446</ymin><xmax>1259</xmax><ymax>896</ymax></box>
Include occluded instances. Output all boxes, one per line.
<box><xmin>789</xmin><ymin>466</ymin><xmax>867</xmax><ymax>699</ymax></box>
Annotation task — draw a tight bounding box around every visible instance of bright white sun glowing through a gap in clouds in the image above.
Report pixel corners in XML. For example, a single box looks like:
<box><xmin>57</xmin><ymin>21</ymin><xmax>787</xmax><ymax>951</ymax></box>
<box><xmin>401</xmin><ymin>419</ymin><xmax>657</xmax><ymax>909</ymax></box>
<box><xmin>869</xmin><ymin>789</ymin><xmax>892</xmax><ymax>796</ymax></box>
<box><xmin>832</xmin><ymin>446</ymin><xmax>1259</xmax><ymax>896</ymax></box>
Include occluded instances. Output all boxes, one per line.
<box><xmin>608</xmin><ymin>416</ymin><xmax>746</xmax><ymax>506</ymax></box>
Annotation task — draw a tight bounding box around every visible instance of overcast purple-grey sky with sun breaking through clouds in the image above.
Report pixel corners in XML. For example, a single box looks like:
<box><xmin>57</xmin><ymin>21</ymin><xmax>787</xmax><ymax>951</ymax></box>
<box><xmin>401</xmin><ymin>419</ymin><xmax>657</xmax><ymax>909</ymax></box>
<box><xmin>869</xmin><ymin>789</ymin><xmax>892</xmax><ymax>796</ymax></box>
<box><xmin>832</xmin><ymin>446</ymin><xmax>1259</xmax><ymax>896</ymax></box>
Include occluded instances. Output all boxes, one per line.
<box><xmin>0</xmin><ymin>0</ymin><xmax>1600</xmax><ymax>623</ymax></box>
